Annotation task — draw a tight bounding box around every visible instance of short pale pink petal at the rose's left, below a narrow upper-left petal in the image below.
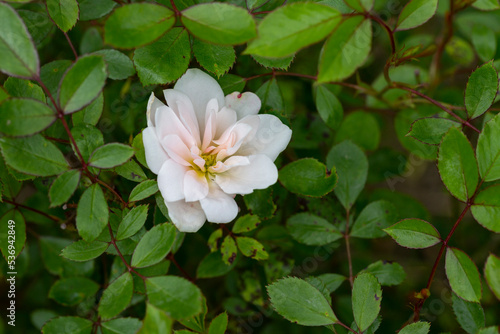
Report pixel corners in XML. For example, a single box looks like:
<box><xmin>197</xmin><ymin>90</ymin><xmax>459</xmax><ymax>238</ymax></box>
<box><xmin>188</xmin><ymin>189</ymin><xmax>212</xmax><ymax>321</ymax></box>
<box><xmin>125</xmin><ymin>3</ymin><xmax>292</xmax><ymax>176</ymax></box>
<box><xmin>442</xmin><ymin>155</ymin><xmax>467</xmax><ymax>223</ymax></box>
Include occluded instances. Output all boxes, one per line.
<box><xmin>156</xmin><ymin>106</ymin><xmax>197</xmax><ymax>147</ymax></box>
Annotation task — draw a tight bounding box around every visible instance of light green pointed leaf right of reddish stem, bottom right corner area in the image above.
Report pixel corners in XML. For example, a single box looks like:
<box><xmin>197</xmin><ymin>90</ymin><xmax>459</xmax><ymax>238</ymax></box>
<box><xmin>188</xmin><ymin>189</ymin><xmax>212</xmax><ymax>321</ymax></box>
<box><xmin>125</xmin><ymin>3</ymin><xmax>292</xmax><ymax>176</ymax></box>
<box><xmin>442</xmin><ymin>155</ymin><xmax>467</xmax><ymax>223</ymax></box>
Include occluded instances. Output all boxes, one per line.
<box><xmin>445</xmin><ymin>248</ymin><xmax>482</xmax><ymax>303</ymax></box>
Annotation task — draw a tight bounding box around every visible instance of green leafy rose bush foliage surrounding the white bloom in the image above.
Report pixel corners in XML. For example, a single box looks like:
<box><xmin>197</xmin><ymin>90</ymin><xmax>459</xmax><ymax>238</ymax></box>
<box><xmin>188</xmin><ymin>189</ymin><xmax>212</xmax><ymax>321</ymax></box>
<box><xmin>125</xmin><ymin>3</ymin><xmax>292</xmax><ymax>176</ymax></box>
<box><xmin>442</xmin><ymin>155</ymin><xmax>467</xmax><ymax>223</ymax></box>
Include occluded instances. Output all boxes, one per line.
<box><xmin>0</xmin><ymin>0</ymin><xmax>500</xmax><ymax>334</ymax></box>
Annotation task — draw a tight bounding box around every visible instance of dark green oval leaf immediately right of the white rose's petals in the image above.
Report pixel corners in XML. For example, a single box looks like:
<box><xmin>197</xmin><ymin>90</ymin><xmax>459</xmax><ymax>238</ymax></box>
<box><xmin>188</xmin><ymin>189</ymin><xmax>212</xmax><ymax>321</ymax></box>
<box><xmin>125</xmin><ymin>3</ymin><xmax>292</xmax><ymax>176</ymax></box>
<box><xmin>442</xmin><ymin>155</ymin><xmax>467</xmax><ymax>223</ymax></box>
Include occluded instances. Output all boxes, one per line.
<box><xmin>279</xmin><ymin>158</ymin><xmax>337</xmax><ymax>197</ymax></box>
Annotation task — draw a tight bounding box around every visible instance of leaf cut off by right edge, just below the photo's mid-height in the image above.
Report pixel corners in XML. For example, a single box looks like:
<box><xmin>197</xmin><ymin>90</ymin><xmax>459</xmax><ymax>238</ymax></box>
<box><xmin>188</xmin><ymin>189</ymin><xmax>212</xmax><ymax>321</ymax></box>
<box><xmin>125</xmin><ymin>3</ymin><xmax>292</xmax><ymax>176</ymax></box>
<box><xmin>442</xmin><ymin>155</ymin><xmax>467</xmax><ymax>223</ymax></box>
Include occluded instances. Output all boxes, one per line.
<box><xmin>471</xmin><ymin>185</ymin><xmax>500</xmax><ymax>233</ymax></box>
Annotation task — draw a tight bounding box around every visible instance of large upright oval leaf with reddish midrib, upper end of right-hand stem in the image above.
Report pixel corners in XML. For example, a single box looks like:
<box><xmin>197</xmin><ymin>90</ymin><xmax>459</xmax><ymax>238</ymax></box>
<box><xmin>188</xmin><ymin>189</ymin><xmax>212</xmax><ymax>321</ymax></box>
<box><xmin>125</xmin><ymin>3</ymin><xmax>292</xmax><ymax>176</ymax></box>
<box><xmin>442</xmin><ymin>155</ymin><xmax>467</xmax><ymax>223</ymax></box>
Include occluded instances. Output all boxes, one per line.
<box><xmin>438</xmin><ymin>128</ymin><xmax>478</xmax><ymax>202</ymax></box>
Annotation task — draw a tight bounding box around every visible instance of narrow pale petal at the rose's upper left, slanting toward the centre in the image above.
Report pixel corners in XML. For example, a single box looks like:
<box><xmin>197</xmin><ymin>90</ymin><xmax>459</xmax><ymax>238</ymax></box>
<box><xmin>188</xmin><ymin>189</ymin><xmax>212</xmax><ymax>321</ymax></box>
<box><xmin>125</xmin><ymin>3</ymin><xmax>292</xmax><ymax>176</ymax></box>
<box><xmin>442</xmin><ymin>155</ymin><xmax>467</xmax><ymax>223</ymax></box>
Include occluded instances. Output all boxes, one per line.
<box><xmin>163</xmin><ymin>89</ymin><xmax>201</xmax><ymax>145</ymax></box>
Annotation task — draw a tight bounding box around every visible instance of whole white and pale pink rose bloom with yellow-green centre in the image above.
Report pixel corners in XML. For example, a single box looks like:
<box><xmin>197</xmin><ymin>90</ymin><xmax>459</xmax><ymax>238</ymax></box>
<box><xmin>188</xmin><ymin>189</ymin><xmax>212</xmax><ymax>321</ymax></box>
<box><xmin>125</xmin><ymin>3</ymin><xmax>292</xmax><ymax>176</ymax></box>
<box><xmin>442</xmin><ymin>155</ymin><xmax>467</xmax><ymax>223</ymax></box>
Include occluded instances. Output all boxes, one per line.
<box><xmin>142</xmin><ymin>69</ymin><xmax>292</xmax><ymax>232</ymax></box>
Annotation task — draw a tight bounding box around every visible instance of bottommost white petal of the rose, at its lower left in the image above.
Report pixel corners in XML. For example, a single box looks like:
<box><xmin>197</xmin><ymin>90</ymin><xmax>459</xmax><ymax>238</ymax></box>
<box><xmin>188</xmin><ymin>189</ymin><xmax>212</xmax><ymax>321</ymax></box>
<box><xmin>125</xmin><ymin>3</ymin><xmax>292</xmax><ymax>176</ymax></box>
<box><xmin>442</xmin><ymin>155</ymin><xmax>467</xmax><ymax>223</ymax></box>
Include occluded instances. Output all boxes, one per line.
<box><xmin>165</xmin><ymin>200</ymin><xmax>207</xmax><ymax>232</ymax></box>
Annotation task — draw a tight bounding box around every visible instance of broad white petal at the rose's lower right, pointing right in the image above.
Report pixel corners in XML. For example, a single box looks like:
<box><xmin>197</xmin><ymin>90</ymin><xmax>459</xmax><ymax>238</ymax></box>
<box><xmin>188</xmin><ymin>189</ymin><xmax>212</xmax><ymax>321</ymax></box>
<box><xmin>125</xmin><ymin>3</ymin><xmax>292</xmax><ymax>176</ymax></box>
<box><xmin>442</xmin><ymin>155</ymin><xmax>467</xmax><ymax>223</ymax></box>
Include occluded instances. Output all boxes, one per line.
<box><xmin>215</xmin><ymin>154</ymin><xmax>278</xmax><ymax>195</ymax></box>
